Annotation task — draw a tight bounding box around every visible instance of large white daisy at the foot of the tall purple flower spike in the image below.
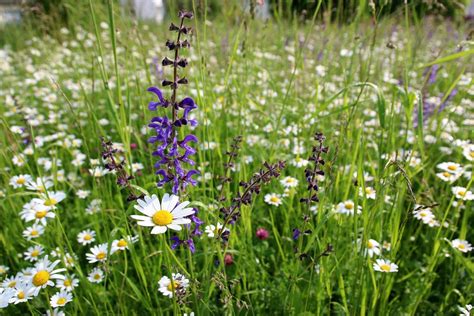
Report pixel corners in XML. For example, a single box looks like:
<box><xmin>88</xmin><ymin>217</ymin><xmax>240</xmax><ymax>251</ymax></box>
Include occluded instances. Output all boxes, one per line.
<box><xmin>131</xmin><ymin>193</ymin><xmax>194</xmax><ymax>234</ymax></box>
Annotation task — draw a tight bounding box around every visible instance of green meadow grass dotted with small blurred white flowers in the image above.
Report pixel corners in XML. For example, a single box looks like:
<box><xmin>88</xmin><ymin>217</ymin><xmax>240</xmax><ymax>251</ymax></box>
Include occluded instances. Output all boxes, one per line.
<box><xmin>0</xmin><ymin>1</ymin><xmax>474</xmax><ymax>315</ymax></box>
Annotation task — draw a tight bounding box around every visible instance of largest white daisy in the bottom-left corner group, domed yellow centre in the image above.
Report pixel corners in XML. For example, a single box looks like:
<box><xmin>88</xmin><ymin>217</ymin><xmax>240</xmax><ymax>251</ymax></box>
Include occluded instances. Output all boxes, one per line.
<box><xmin>29</xmin><ymin>256</ymin><xmax>66</xmax><ymax>296</ymax></box>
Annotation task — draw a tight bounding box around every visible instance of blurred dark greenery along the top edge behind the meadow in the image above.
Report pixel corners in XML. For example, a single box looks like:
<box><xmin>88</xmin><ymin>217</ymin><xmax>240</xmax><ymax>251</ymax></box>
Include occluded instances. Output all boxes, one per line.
<box><xmin>0</xmin><ymin>0</ymin><xmax>472</xmax><ymax>46</ymax></box>
